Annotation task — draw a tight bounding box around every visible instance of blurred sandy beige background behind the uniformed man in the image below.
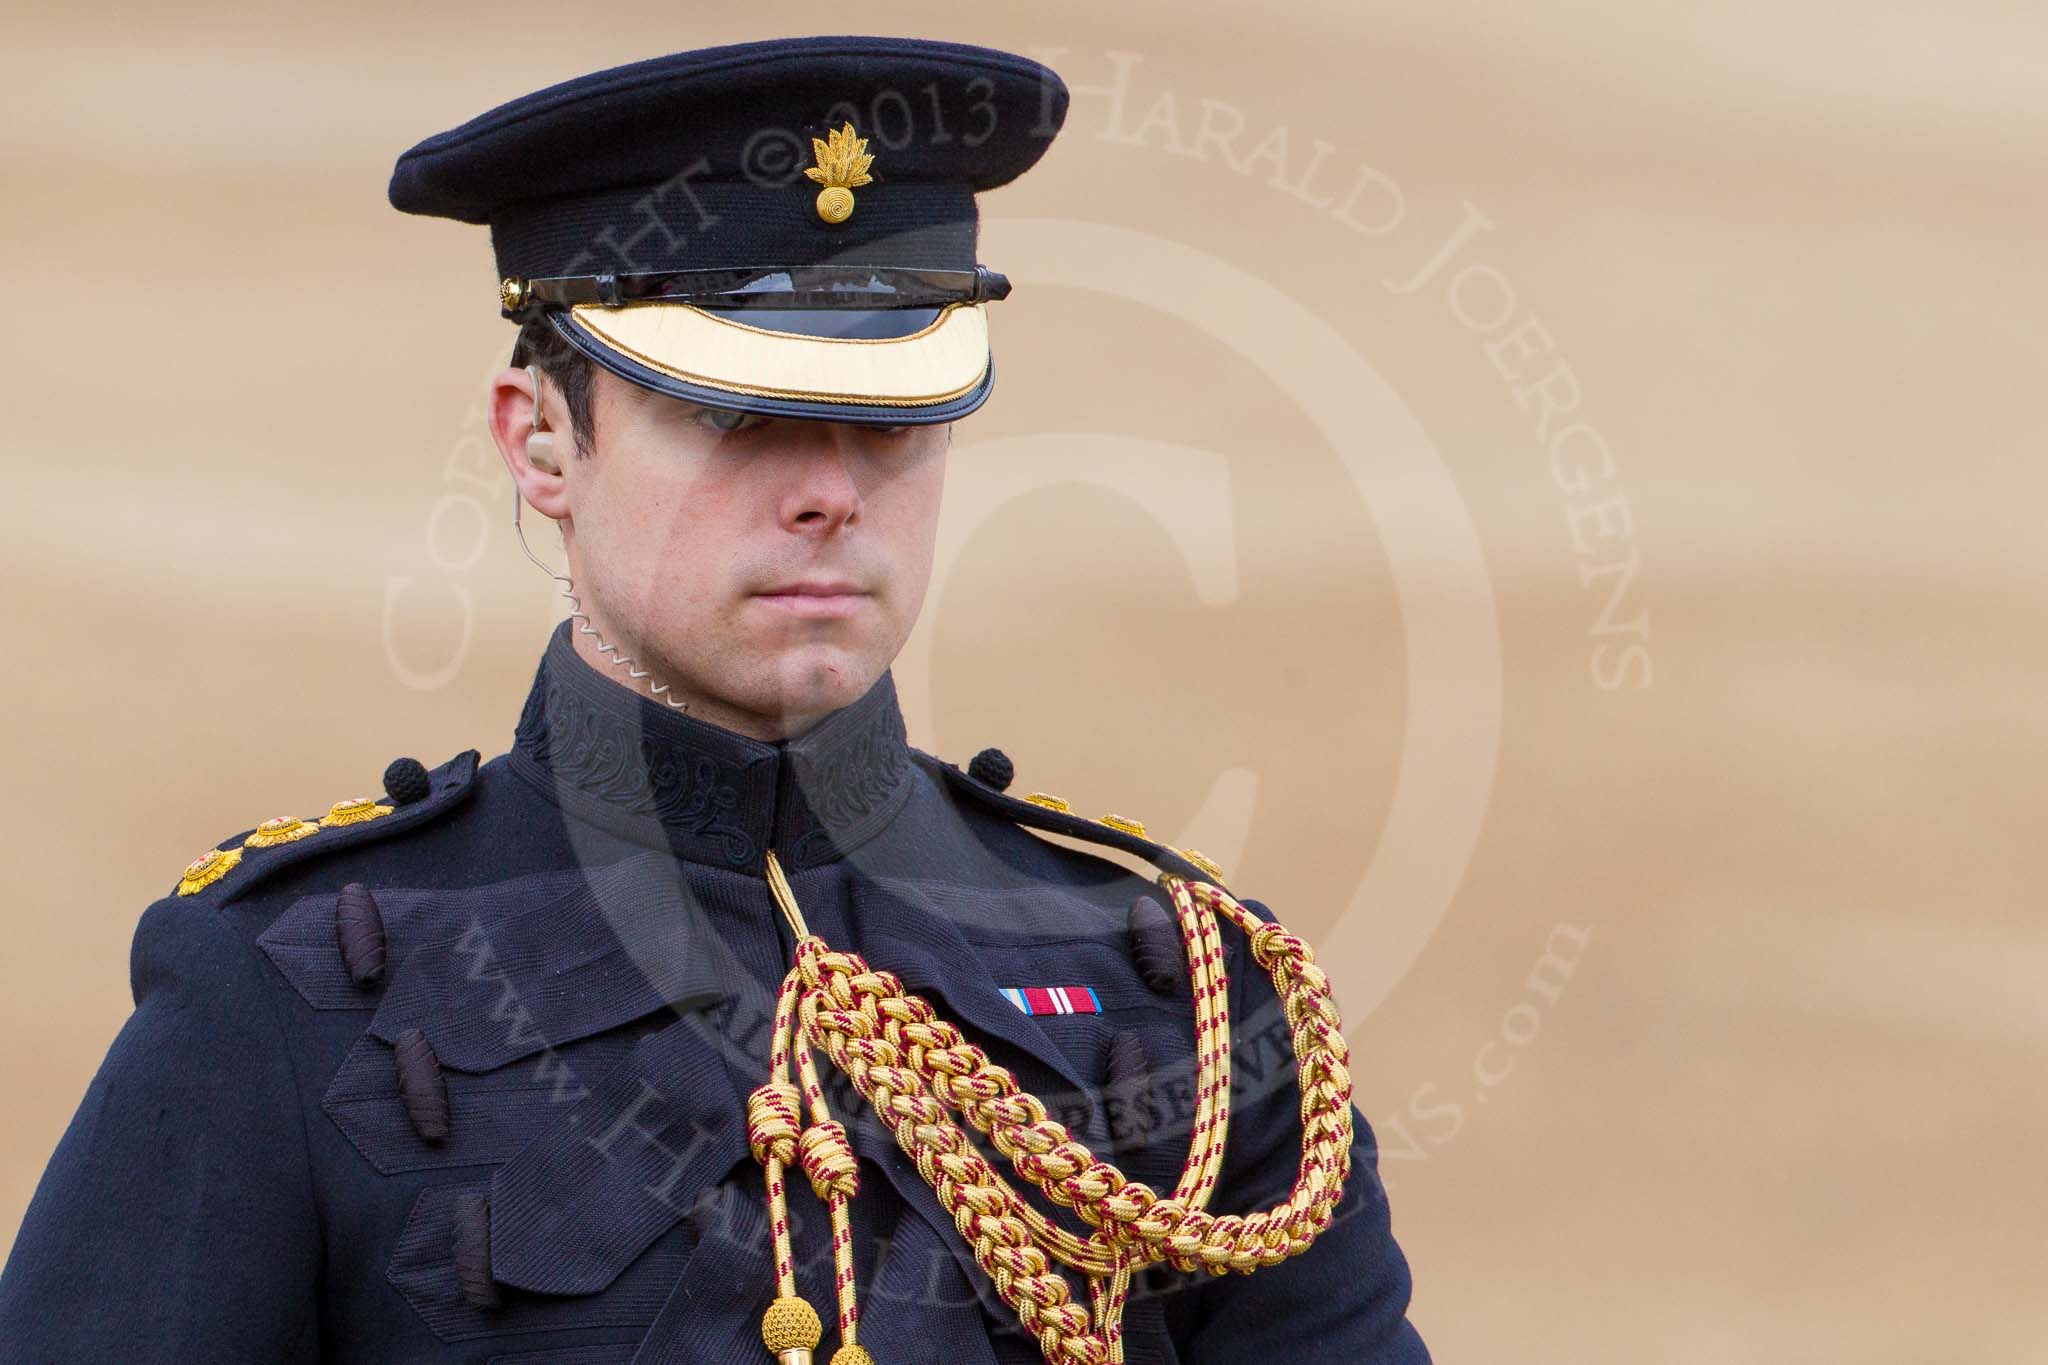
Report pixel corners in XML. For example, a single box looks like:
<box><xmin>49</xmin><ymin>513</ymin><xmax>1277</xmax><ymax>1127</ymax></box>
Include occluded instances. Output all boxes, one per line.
<box><xmin>0</xmin><ymin>0</ymin><xmax>2048</xmax><ymax>1365</ymax></box>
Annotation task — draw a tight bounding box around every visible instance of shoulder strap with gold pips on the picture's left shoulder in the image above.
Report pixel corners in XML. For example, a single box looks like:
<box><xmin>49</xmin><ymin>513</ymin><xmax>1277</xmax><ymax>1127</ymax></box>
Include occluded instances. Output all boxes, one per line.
<box><xmin>170</xmin><ymin>749</ymin><xmax>481</xmax><ymax>905</ymax></box>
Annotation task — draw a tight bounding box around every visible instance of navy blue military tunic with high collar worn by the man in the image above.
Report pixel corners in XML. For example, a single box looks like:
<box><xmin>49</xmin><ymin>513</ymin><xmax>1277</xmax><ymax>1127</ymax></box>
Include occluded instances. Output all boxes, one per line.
<box><xmin>0</xmin><ymin>626</ymin><xmax>1427</xmax><ymax>1365</ymax></box>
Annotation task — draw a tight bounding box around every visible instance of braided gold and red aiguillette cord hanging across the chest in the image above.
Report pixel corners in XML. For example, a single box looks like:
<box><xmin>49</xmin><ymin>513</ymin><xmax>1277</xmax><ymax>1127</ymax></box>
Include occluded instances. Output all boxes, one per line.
<box><xmin>748</xmin><ymin>851</ymin><xmax>1352</xmax><ymax>1365</ymax></box>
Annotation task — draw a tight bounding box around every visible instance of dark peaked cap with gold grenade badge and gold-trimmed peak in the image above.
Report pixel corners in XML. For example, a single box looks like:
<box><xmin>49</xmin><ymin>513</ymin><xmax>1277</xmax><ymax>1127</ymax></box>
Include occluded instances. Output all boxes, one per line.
<box><xmin>389</xmin><ymin>37</ymin><xmax>1067</xmax><ymax>424</ymax></box>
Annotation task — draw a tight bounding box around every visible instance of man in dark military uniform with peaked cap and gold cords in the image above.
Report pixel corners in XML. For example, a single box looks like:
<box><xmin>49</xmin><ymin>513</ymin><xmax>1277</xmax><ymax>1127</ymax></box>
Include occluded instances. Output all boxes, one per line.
<box><xmin>0</xmin><ymin>37</ymin><xmax>1427</xmax><ymax>1365</ymax></box>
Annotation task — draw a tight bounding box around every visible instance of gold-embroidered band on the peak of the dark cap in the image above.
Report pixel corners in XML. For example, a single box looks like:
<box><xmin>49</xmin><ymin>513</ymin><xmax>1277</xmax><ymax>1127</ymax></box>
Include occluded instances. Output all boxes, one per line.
<box><xmin>569</xmin><ymin>301</ymin><xmax>989</xmax><ymax>407</ymax></box>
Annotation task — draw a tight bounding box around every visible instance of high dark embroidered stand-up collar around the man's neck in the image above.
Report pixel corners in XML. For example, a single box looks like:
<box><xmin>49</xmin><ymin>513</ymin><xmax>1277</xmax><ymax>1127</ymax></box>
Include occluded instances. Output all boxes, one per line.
<box><xmin>510</xmin><ymin>620</ymin><xmax>913</xmax><ymax>874</ymax></box>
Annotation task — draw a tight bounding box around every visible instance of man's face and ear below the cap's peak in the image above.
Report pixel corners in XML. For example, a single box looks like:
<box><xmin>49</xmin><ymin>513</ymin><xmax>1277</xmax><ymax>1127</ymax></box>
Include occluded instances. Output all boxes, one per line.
<box><xmin>492</xmin><ymin>370</ymin><xmax>950</xmax><ymax>739</ymax></box>
